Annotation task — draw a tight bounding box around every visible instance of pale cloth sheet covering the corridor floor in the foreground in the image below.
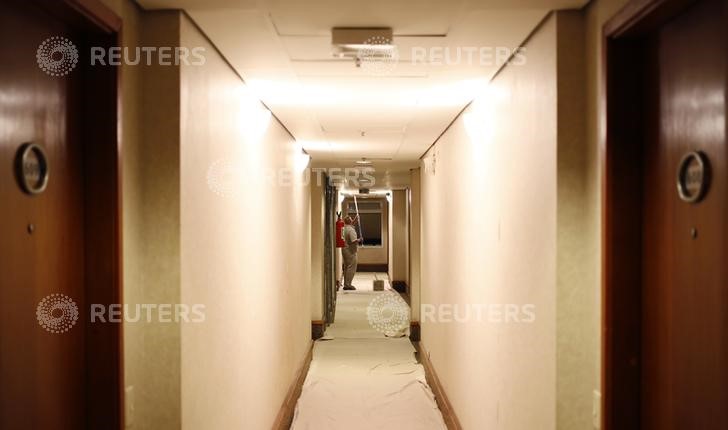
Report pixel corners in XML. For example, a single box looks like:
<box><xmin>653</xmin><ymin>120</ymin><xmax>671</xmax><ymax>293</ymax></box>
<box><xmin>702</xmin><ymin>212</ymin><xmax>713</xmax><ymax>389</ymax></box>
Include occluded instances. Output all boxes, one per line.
<box><xmin>291</xmin><ymin>274</ymin><xmax>446</xmax><ymax>430</ymax></box>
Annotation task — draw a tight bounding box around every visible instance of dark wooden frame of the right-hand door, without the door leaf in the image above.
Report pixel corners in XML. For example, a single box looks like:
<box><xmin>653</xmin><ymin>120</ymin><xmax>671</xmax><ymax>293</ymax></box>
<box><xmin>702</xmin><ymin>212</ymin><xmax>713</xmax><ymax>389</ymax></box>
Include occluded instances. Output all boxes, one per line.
<box><xmin>599</xmin><ymin>0</ymin><xmax>697</xmax><ymax>430</ymax></box>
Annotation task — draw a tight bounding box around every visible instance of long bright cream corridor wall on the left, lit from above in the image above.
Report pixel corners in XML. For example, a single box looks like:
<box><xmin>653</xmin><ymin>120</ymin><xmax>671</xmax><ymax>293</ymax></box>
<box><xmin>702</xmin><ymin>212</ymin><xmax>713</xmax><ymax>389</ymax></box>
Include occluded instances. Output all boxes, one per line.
<box><xmin>181</xmin><ymin>17</ymin><xmax>311</xmax><ymax>429</ymax></box>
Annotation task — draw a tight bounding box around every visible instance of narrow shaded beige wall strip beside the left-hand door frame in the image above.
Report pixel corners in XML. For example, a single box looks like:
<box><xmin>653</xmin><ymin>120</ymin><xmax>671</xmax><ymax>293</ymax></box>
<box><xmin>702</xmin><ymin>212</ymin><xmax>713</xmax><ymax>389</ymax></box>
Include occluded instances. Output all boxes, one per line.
<box><xmin>96</xmin><ymin>0</ymin><xmax>181</xmax><ymax>429</ymax></box>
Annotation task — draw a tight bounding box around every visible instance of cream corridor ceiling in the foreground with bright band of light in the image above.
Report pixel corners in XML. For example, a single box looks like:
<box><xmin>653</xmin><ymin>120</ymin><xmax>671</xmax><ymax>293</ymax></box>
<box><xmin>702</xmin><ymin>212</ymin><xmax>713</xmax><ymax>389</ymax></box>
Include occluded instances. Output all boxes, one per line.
<box><xmin>138</xmin><ymin>0</ymin><xmax>587</xmax><ymax>186</ymax></box>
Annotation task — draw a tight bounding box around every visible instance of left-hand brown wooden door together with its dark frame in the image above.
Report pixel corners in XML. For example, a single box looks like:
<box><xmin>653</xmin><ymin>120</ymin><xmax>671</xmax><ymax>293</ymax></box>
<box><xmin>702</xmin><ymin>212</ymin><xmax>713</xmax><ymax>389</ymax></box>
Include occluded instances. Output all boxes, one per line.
<box><xmin>0</xmin><ymin>0</ymin><xmax>123</xmax><ymax>430</ymax></box>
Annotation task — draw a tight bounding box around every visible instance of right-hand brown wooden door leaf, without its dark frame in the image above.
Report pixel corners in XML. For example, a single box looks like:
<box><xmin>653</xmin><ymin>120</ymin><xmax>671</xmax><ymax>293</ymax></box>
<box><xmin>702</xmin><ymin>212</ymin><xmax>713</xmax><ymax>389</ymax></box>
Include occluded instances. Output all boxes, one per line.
<box><xmin>642</xmin><ymin>0</ymin><xmax>728</xmax><ymax>430</ymax></box>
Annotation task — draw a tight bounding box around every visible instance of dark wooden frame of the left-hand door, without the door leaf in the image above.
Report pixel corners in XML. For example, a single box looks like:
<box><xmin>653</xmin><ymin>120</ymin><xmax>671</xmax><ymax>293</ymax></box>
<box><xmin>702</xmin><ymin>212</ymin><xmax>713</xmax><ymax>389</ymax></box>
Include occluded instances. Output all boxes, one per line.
<box><xmin>34</xmin><ymin>0</ymin><xmax>124</xmax><ymax>424</ymax></box>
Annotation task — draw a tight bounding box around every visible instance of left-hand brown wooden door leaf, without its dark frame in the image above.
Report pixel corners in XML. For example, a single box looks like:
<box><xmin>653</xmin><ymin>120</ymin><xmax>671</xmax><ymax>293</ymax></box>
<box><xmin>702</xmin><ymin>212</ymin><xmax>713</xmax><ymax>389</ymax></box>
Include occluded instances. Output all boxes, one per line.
<box><xmin>0</xmin><ymin>2</ymin><xmax>86</xmax><ymax>429</ymax></box>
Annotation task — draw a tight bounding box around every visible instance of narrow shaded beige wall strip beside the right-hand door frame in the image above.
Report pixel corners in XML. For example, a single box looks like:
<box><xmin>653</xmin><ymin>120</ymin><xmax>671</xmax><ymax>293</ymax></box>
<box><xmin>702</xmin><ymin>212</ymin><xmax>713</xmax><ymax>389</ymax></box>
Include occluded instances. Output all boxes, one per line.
<box><xmin>557</xmin><ymin>0</ymin><xmax>628</xmax><ymax>430</ymax></box>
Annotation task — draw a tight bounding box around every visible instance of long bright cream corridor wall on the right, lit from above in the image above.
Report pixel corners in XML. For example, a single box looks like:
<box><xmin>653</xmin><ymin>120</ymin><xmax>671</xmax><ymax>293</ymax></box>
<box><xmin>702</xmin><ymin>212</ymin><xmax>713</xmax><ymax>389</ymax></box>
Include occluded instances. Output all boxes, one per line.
<box><xmin>420</xmin><ymin>18</ymin><xmax>557</xmax><ymax>430</ymax></box>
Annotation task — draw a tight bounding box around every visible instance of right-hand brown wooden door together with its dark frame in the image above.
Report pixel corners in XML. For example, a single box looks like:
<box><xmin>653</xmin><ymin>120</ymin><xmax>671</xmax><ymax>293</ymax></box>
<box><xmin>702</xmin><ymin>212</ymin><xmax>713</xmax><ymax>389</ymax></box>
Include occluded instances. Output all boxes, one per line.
<box><xmin>602</xmin><ymin>0</ymin><xmax>728</xmax><ymax>430</ymax></box>
